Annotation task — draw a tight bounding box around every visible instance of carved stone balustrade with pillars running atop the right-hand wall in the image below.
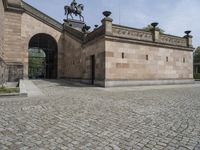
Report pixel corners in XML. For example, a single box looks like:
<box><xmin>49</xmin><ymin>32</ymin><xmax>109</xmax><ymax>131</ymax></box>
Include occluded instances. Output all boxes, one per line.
<box><xmin>86</xmin><ymin>18</ymin><xmax>193</xmax><ymax>48</ymax></box>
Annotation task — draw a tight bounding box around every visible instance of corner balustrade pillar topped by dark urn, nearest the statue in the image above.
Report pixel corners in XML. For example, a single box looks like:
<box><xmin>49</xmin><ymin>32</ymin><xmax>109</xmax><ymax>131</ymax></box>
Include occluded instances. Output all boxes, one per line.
<box><xmin>101</xmin><ymin>11</ymin><xmax>113</xmax><ymax>35</ymax></box>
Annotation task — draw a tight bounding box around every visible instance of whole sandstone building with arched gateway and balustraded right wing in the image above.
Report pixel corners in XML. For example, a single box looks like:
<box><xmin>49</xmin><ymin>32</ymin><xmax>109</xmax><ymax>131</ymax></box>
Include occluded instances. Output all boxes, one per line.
<box><xmin>0</xmin><ymin>0</ymin><xmax>193</xmax><ymax>87</ymax></box>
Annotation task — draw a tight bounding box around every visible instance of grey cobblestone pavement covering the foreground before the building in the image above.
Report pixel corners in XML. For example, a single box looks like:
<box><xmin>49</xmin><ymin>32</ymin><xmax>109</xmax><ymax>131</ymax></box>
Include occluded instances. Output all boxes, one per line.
<box><xmin>0</xmin><ymin>81</ymin><xmax>200</xmax><ymax>150</ymax></box>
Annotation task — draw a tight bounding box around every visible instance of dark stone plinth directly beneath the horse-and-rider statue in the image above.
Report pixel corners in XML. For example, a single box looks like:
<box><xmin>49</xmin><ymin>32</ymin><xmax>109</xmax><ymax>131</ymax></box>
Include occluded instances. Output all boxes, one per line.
<box><xmin>64</xmin><ymin>19</ymin><xmax>85</xmax><ymax>31</ymax></box>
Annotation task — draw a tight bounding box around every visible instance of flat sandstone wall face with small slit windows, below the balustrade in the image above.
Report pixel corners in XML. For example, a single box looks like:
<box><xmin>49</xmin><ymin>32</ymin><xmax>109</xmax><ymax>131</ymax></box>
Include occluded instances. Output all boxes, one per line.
<box><xmin>106</xmin><ymin>41</ymin><xmax>193</xmax><ymax>80</ymax></box>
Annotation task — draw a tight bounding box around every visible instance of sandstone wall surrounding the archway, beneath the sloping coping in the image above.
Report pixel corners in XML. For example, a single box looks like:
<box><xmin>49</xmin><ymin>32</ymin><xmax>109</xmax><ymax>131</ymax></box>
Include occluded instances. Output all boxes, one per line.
<box><xmin>20</xmin><ymin>13</ymin><xmax>63</xmax><ymax>78</ymax></box>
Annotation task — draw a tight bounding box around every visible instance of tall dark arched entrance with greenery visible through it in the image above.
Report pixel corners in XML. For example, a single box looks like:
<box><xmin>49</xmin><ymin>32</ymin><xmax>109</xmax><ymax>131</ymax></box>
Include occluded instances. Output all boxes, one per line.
<box><xmin>29</xmin><ymin>33</ymin><xmax>58</xmax><ymax>79</ymax></box>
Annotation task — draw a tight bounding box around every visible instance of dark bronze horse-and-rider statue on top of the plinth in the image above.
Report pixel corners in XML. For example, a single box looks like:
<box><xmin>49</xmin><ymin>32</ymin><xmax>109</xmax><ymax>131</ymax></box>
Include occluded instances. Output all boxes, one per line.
<box><xmin>64</xmin><ymin>0</ymin><xmax>84</xmax><ymax>22</ymax></box>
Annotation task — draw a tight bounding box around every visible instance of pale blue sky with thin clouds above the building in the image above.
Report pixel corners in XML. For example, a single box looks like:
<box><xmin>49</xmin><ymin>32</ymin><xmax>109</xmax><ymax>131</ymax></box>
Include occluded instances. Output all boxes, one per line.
<box><xmin>24</xmin><ymin>0</ymin><xmax>200</xmax><ymax>47</ymax></box>
